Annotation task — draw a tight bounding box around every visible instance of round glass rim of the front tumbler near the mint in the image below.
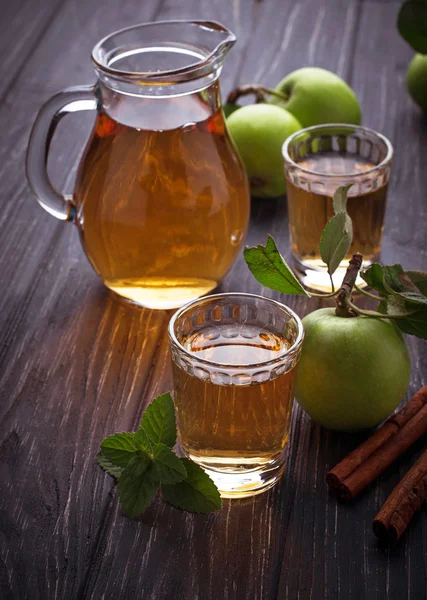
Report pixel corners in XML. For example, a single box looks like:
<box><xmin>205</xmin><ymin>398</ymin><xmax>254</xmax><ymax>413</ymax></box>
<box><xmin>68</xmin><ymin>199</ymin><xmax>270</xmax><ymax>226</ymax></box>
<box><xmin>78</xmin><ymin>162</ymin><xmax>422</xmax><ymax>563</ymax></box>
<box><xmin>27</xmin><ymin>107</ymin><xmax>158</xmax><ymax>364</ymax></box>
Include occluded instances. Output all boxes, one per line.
<box><xmin>168</xmin><ymin>292</ymin><xmax>304</xmax><ymax>371</ymax></box>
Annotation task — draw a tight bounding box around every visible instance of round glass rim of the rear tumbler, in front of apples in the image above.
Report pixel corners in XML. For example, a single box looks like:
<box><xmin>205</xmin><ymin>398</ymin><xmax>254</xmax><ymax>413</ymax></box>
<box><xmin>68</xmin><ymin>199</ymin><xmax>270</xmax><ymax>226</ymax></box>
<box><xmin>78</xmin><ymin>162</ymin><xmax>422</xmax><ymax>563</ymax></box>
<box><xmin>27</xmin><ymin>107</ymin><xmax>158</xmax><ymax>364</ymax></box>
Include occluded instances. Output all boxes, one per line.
<box><xmin>282</xmin><ymin>123</ymin><xmax>394</xmax><ymax>179</ymax></box>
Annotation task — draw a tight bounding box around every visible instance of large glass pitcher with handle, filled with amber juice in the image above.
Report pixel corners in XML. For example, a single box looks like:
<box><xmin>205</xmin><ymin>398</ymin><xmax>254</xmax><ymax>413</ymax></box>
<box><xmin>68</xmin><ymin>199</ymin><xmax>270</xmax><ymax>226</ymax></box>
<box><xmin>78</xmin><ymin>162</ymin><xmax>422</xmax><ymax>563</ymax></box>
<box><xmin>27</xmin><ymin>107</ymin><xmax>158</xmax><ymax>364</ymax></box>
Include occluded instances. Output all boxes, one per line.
<box><xmin>27</xmin><ymin>21</ymin><xmax>250</xmax><ymax>309</ymax></box>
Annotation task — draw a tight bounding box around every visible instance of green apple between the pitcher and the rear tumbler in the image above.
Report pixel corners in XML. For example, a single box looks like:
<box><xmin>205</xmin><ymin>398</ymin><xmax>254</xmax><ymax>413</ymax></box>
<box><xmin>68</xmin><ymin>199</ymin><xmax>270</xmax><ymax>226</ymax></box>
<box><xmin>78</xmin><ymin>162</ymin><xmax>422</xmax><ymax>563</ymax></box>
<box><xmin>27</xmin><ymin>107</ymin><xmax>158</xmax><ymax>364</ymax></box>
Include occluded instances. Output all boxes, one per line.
<box><xmin>227</xmin><ymin>104</ymin><xmax>301</xmax><ymax>198</ymax></box>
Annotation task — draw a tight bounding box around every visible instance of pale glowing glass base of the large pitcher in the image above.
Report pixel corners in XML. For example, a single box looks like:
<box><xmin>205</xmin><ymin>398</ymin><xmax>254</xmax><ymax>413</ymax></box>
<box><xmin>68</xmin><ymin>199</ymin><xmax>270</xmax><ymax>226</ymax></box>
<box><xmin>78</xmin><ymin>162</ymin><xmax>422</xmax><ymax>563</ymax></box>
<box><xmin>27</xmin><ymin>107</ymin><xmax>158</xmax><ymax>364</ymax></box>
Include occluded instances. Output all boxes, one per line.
<box><xmin>104</xmin><ymin>278</ymin><xmax>218</xmax><ymax>310</ymax></box>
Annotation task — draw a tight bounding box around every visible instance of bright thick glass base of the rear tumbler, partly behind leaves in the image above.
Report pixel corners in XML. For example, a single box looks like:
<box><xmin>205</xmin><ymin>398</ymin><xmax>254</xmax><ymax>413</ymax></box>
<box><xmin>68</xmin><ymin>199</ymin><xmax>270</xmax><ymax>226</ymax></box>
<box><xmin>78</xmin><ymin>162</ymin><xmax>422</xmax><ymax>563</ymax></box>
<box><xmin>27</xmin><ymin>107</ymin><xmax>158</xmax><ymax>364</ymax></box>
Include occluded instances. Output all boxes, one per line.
<box><xmin>293</xmin><ymin>255</ymin><xmax>372</xmax><ymax>293</ymax></box>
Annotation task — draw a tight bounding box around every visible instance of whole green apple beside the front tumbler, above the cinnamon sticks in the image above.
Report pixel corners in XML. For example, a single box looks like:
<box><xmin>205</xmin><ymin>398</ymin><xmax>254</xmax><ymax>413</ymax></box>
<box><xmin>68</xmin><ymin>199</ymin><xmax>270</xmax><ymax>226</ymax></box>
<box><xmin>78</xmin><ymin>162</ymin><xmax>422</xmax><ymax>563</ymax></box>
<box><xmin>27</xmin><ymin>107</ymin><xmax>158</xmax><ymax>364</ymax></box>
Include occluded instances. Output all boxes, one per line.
<box><xmin>295</xmin><ymin>308</ymin><xmax>411</xmax><ymax>431</ymax></box>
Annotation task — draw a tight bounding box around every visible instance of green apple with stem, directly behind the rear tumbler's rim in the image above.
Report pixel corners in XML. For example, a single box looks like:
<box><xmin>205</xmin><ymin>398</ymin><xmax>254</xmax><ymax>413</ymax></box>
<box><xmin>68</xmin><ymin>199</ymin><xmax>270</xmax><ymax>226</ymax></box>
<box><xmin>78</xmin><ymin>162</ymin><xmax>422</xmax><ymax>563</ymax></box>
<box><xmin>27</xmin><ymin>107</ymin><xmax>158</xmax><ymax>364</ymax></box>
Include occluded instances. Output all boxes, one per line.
<box><xmin>269</xmin><ymin>67</ymin><xmax>361</xmax><ymax>127</ymax></box>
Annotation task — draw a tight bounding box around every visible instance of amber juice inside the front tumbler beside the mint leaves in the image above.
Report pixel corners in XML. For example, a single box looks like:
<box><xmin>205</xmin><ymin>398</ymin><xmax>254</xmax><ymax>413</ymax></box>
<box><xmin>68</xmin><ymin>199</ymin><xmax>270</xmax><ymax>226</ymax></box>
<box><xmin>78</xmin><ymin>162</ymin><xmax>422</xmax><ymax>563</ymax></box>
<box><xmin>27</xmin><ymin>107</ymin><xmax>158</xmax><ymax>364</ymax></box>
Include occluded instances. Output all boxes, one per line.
<box><xmin>173</xmin><ymin>324</ymin><xmax>294</xmax><ymax>470</ymax></box>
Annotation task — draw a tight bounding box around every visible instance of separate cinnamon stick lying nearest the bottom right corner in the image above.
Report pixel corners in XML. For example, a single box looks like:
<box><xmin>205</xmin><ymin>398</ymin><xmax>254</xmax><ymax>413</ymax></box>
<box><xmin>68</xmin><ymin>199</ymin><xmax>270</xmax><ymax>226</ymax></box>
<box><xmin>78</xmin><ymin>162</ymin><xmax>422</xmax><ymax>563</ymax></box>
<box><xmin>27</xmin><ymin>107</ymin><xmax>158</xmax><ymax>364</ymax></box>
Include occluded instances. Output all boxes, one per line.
<box><xmin>372</xmin><ymin>451</ymin><xmax>427</xmax><ymax>543</ymax></box>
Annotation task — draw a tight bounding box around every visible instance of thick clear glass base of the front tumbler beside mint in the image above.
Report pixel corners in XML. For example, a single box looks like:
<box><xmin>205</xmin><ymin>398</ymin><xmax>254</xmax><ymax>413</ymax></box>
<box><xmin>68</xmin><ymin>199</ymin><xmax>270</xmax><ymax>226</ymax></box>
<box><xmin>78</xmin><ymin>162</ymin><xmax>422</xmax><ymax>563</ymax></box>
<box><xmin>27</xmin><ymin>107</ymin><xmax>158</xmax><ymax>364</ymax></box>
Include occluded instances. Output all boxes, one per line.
<box><xmin>187</xmin><ymin>451</ymin><xmax>285</xmax><ymax>498</ymax></box>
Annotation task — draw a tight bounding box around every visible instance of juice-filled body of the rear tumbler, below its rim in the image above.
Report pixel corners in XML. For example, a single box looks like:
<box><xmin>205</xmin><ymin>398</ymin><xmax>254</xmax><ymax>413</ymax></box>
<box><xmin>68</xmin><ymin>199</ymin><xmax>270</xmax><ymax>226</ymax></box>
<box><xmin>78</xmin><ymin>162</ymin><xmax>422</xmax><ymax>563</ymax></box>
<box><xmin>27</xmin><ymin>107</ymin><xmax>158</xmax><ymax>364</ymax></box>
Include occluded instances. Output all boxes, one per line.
<box><xmin>287</xmin><ymin>151</ymin><xmax>388</xmax><ymax>291</ymax></box>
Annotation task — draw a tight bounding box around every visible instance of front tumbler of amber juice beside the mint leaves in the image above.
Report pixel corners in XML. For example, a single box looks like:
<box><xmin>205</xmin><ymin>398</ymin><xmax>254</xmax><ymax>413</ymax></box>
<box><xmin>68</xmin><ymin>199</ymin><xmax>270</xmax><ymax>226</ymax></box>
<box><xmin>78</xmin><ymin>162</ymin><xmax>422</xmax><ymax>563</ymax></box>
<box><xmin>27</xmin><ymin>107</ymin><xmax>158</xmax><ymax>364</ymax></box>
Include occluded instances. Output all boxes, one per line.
<box><xmin>169</xmin><ymin>293</ymin><xmax>303</xmax><ymax>498</ymax></box>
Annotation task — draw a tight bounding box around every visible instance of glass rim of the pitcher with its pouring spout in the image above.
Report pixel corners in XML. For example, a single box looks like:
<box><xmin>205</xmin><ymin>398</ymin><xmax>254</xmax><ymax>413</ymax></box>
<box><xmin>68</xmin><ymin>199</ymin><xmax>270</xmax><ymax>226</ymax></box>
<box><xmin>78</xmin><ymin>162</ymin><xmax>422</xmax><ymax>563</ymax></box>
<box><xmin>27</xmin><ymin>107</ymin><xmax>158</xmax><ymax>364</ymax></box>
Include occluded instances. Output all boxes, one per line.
<box><xmin>91</xmin><ymin>19</ymin><xmax>236</xmax><ymax>83</ymax></box>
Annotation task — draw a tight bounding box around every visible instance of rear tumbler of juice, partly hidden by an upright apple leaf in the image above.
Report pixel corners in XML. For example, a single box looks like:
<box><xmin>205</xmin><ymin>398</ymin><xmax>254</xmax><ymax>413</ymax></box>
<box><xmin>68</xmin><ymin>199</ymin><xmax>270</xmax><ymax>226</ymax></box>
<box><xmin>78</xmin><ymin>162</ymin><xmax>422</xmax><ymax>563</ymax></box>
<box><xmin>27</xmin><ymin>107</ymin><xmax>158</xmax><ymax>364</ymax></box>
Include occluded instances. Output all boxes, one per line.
<box><xmin>283</xmin><ymin>124</ymin><xmax>393</xmax><ymax>291</ymax></box>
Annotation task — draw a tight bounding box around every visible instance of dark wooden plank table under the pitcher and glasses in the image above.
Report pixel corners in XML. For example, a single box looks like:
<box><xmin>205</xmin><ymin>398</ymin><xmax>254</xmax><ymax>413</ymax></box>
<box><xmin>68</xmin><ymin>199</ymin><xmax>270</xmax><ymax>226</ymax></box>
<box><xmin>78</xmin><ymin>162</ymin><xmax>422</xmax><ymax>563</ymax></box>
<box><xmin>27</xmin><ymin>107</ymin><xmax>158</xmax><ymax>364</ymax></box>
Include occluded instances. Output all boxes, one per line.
<box><xmin>0</xmin><ymin>0</ymin><xmax>427</xmax><ymax>600</ymax></box>
